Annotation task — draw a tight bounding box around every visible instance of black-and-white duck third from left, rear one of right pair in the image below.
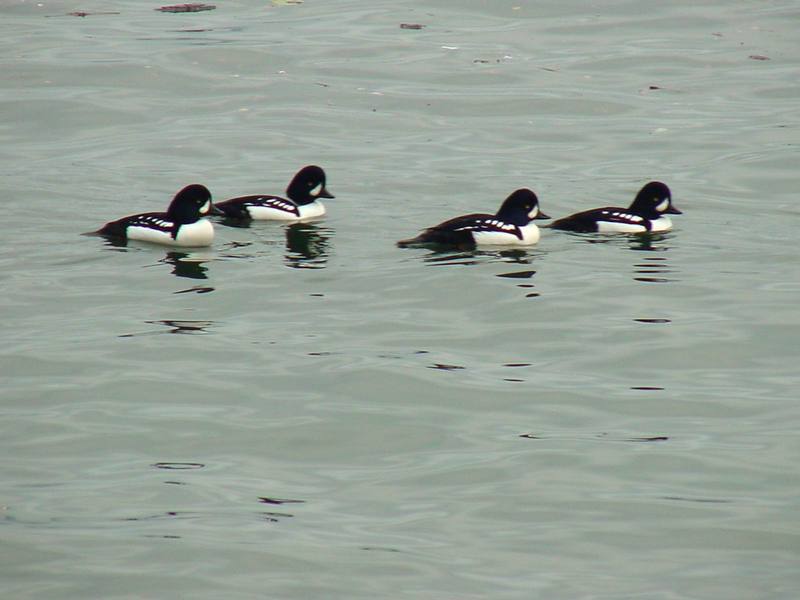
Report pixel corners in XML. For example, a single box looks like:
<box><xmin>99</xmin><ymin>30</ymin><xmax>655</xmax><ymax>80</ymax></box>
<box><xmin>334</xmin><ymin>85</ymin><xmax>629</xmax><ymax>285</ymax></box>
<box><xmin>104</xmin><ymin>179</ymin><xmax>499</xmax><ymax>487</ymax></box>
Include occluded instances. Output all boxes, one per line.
<box><xmin>397</xmin><ymin>188</ymin><xmax>550</xmax><ymax>248</ymax></box>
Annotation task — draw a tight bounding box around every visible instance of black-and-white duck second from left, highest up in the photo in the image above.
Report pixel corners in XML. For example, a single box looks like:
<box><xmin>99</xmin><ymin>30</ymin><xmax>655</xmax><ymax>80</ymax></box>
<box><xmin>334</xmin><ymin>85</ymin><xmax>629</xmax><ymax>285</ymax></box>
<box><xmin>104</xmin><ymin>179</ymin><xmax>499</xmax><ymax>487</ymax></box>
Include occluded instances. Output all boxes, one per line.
<box><xmin>212</xmin><ymin>165</ymin><xmax>335</xmax><ymax>221</ymax></box>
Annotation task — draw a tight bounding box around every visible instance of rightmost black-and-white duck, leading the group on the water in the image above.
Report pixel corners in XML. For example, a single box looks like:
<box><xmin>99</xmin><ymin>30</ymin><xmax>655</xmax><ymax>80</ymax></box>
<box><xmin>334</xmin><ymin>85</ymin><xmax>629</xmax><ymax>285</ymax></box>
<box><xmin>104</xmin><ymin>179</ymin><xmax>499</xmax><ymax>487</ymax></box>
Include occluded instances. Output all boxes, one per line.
<box><xmin>549</xmin><ymin>181</ymin><xmax>683</xmax><ymax>233</ymax></box>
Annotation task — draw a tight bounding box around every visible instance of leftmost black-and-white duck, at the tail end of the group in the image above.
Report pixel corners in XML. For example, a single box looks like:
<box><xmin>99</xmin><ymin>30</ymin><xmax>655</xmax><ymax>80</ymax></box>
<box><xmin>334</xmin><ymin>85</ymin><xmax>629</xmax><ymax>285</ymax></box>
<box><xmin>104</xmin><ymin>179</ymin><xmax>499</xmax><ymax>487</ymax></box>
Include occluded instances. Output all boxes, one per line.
<box><xmin>94</xmin><ymin>183</ymin><xmax>214</xmax><ymax>248</ymax></box>
